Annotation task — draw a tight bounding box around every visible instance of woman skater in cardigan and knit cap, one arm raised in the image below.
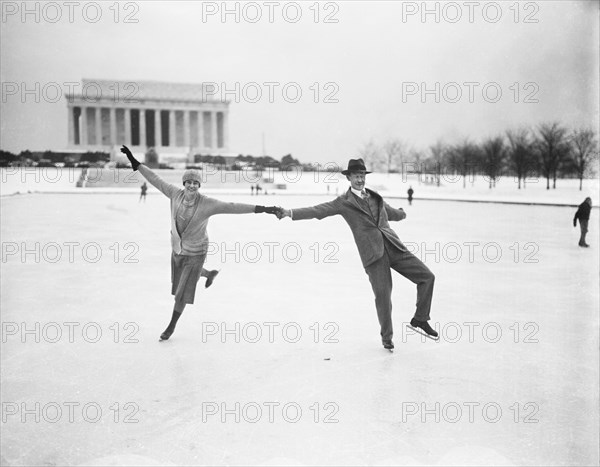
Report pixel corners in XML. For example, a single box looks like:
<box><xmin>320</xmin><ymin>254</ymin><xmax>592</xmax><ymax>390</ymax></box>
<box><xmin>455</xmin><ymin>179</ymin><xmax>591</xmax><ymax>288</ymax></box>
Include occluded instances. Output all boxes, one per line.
<box><xmin>121</xmin><ymin>146</ymin><xmax>279</xmax><ymax>340</ymax></box>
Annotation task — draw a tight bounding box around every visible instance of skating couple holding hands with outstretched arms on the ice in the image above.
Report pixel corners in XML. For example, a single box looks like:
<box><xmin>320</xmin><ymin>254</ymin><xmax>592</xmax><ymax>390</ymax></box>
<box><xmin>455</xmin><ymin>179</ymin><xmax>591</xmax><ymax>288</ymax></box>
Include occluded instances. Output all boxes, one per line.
<box><xmin>121</xmin><ymin>146</ymin><xmax>438</xmax><ymax>350</ymax></box>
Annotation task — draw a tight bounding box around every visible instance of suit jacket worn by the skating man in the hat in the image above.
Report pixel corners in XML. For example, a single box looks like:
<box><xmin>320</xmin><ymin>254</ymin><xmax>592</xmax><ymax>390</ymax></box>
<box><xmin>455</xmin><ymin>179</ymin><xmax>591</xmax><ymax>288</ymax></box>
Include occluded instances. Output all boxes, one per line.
<box><xmin>292</xmin><ymin>189</ymin><xmax>408</xmax><ymax>267</ymax></box>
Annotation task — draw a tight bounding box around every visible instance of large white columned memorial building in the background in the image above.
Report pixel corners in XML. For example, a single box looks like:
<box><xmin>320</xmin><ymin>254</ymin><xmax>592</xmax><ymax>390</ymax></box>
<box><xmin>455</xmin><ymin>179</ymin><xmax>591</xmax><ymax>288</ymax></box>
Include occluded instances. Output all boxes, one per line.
<box><xmin>67</xmin><ymin>79</ymin><xmax>229</xmax><ymax>163</ymax></box>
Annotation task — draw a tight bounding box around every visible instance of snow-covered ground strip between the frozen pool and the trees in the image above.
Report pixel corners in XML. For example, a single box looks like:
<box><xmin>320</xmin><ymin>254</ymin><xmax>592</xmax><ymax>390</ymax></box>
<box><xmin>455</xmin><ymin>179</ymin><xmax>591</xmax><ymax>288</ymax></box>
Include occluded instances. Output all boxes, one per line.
<box><xmin>0</xmin><ymin>167</ymin><xmax>600</xmax><ymax>206</ymax></box>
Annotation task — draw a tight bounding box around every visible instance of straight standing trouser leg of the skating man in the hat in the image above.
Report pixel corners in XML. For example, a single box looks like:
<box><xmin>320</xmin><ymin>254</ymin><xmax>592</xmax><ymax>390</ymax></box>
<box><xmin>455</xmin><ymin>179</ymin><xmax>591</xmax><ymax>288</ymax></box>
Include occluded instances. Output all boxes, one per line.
<box><xmin>365</xmin><ymin>253</ymin><xmax>394</xmax><ymax>342</ymax></box>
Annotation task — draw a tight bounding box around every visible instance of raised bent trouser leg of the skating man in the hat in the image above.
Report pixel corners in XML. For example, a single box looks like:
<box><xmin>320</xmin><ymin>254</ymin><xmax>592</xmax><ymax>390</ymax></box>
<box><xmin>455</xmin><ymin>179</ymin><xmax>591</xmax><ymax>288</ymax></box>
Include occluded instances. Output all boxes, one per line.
<box><xmin>386</xmin><ymin>249</ymin><xmax>435</xmax><ymax>321</ymax></box>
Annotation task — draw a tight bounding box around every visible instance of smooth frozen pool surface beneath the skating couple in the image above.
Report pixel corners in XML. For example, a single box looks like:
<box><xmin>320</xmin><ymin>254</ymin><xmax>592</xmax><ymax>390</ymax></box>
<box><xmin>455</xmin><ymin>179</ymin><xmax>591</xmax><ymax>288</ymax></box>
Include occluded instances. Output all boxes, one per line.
<box><xmin>0</xmin><ymin>194</ymin><xmax>600</xmax><ymax>465</ymax></box>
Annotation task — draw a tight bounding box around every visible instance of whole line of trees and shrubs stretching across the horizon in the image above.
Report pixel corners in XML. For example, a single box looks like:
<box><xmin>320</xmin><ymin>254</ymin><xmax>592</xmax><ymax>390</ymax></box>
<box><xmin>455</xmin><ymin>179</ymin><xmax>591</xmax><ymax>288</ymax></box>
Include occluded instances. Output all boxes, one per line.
<box><xmin>0</xmin><ymin>122</ymin><xmax>599</xmax><ymax>190</ymax></box>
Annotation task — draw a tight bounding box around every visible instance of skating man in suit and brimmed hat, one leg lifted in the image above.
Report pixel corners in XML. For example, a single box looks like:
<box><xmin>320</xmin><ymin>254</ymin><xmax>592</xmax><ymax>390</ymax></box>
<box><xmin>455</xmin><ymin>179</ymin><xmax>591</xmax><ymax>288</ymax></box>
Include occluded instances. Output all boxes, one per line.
<box><xmin>278</xmin><ymin>159</ymin><xmax>438</xmax><ymax>350</ymax></box>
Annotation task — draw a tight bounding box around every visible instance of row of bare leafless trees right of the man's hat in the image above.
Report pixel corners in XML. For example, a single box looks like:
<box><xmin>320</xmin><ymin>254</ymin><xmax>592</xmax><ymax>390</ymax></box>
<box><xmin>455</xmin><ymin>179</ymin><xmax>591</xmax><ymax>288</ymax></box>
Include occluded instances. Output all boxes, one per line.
<box><xmin>358</xmin><ymin>122</ymin><xmax>599</xmax><ymax>190</ymax></box>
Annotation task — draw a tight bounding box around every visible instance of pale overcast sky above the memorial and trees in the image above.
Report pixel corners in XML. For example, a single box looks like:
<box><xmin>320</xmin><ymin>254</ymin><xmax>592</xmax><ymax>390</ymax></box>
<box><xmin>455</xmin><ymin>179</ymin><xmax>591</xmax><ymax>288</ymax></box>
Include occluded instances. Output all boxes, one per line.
<box><xmin>0</xmin><ymin>1</ymin><xmax>600</xmax><ymax>163</ymax></box>
